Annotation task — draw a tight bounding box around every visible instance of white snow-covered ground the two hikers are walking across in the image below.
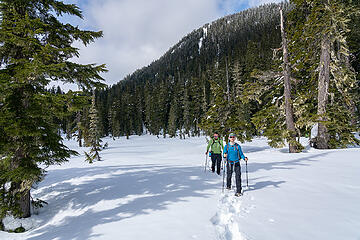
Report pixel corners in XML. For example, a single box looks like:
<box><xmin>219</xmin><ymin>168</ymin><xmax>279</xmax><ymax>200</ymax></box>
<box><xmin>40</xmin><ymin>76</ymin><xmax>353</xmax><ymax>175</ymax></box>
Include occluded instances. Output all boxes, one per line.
<box><xmin>0</xmin><ymin>136</ymin><xmax>360</xmax><ymax>240</ymax></box>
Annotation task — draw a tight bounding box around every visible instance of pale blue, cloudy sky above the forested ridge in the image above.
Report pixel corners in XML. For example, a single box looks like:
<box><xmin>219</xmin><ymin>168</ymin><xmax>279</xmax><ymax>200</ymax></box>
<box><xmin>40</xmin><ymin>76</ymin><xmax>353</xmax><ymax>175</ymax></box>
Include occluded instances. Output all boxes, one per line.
<box><xmin>62</xmin><ymin>0</ymin><xmax>281</xmax><ymax>89</ymax></box>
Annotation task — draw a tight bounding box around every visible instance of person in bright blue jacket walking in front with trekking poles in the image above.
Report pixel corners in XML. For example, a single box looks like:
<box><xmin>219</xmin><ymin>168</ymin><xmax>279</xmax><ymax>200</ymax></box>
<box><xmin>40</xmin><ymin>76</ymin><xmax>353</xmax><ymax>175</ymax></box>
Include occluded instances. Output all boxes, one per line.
<box><xmin>223</xmin><ymin>133</ymin><xmax>248</xmax><ymax>197</ymax></box>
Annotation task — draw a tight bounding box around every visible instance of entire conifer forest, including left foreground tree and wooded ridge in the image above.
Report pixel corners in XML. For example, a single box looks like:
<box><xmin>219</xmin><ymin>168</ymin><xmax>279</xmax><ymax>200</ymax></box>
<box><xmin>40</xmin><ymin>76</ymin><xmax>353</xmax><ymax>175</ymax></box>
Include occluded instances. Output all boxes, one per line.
<box><xmin>0</xmin><ymin>0</ymin><xmax>360</xmax><ymax>223</ymax></box>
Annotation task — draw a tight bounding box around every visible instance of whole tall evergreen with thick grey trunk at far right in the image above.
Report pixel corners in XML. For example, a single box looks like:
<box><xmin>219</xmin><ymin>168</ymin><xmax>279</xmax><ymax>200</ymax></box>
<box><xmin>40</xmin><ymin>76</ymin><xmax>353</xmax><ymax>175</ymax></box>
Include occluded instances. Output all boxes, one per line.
<box><xmin>290</xmin><ymin>0</ymin><xmax>358</xmax><ymax>148</ymax></box>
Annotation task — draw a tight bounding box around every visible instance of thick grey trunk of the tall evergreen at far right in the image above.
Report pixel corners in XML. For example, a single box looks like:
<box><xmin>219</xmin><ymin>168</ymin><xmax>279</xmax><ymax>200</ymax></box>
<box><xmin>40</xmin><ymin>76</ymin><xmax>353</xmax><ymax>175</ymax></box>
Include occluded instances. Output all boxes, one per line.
<box><xmin>315</xmin><ymin>34</ymin><xmax>331</xmax><ymax>149</ymax></box>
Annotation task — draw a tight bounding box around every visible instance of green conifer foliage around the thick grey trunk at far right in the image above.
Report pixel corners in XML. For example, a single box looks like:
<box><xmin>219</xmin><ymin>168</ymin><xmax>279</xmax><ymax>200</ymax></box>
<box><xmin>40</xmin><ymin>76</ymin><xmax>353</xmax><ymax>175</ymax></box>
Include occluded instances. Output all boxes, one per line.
<box><xmin>288</xmin><ymin>0</ymin><xmax>360</xmax><ymax>148</ymax></box>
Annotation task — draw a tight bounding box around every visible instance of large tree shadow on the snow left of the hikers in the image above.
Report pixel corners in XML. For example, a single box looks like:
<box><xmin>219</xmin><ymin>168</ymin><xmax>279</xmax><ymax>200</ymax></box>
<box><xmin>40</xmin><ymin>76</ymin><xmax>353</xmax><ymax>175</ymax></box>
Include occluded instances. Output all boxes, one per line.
<box><xmin>27</xmin><ymin>164</ymin><xmax>218</xmax><ymax>240</ymax></box>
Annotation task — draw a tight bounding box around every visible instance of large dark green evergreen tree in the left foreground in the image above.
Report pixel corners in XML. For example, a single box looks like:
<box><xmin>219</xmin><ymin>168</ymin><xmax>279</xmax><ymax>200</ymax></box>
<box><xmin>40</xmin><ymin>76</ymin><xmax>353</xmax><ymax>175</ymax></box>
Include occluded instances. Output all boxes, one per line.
<box><xmin>0</xmin><ymin>0</ymin><xmax>105</xmax><ymax>219</ymax></box>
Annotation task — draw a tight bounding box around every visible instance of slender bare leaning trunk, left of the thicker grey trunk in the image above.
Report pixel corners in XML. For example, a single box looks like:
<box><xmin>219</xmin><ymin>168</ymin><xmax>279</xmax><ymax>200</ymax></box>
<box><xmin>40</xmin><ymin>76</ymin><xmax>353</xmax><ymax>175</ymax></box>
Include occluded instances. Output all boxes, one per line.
<box><xmin>280</xmin><ymin>7</ymin><xmax>298</xmax><ymax>153</ymax></box>
